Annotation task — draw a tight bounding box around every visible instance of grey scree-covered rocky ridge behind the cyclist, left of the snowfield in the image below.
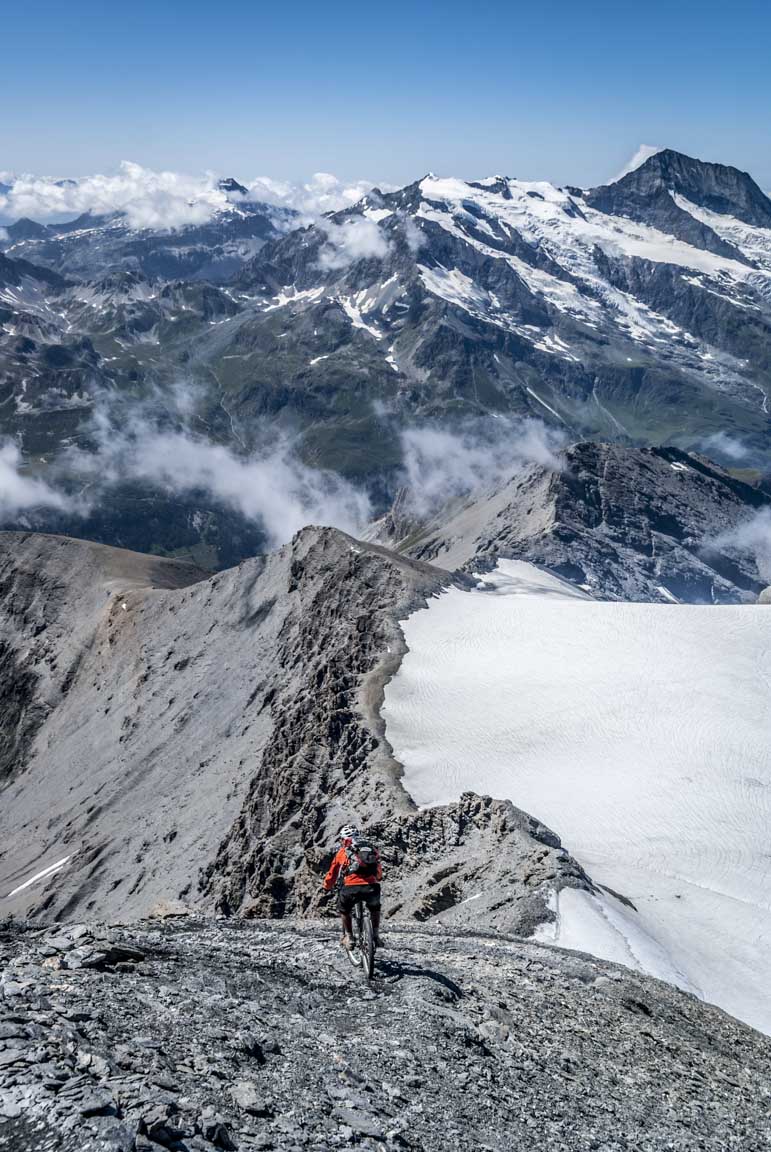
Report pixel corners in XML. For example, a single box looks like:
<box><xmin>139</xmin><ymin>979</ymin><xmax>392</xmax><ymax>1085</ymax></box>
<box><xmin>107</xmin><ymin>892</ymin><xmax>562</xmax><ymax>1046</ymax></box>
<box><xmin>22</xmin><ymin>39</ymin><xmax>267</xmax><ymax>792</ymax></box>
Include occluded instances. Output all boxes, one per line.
<box><xmin>0</xmin><ymin>529</ymin><xmax>591</xmax><ymax>934</ymax></box>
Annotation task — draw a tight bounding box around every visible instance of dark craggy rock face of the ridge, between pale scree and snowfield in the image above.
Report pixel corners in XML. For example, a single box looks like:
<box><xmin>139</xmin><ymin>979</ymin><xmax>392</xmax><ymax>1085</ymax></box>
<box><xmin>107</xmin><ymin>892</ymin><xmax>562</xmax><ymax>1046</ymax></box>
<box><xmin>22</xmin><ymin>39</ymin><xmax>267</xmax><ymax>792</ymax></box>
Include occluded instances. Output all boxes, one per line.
<box><xmin>204</xmin><ymin>531</ymin><xmax>449</xmax><ymax>916</ymax></box>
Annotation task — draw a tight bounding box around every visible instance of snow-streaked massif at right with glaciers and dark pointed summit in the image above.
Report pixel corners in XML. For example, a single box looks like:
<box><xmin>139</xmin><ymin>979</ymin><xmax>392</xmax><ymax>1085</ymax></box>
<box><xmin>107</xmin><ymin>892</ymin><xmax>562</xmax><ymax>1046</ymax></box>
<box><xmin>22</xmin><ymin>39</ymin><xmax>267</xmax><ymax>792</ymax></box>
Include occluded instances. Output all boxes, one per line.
<box><xmin>227</xmin><ymin>153</ymin><xmax>771</xmax><ymax>467</ymax></box>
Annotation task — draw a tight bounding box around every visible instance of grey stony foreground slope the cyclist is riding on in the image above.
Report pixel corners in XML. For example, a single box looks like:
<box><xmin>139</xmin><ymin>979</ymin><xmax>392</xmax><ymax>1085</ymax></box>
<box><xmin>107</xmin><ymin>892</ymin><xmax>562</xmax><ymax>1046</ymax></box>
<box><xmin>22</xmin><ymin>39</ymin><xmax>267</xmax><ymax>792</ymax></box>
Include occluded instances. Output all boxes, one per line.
<box><xmin>0</xmin><ymin>918</ymin><xmax>771</xmax><ymax>1152</ymax></box>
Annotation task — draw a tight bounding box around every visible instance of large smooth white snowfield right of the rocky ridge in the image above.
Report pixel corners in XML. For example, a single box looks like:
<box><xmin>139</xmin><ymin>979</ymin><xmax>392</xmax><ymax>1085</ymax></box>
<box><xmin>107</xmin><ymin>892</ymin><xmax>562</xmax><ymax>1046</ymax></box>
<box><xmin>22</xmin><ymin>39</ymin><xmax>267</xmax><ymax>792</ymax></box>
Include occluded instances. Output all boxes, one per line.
<box><xmin>383</xmin><ymin>561</ymin><xmax>771</xmax><ymax>1032</ymax></box>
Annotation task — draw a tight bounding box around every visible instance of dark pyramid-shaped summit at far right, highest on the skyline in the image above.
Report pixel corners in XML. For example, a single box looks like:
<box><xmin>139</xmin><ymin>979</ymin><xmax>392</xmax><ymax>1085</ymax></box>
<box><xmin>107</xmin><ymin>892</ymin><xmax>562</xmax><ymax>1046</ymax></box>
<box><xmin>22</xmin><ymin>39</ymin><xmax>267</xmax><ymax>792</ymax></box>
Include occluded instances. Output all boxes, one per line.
<box><xmin>597</xmin><ymin>149</ymin><xmax>771</xmax><ymax>228</ymax></box>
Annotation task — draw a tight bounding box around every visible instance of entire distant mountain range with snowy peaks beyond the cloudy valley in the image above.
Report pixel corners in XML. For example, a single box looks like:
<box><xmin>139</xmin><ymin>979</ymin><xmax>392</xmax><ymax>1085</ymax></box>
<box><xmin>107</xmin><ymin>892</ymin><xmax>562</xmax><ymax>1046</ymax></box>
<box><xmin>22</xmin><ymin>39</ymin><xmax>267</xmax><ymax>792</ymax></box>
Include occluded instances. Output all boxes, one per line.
<box><xmin>0</xmin><ymin>151</ymin><xmax>771</xmax><ymax>563</ymax></box>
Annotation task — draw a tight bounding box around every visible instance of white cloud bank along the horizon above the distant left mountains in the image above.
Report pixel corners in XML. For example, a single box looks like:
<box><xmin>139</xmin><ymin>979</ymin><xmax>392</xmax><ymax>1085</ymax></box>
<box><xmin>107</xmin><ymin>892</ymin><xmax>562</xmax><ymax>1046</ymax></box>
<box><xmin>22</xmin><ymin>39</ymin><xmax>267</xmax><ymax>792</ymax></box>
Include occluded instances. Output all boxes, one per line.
<box><xmin>0</xmin><ymin>160</ymin><xmax>384</xmax><ymax>230</ymax></box>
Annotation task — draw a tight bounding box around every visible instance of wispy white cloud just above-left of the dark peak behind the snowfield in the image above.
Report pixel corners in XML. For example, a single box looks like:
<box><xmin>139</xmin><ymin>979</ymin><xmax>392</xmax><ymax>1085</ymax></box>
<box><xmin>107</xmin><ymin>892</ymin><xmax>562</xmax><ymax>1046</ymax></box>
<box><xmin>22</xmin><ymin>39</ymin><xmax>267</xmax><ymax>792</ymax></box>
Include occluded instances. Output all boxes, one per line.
<box><xmin>401</xmin><ymin>417</ymin><xmax>564</xmax><ymax>516</ymax></box>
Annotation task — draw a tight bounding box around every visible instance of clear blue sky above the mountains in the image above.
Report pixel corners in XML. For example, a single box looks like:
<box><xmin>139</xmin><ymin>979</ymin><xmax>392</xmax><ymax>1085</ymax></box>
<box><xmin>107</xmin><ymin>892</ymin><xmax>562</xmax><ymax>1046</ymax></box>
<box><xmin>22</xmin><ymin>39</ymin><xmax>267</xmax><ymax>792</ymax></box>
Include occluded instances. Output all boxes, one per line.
<box><xmin>6</xmin><ymin>0</ymin><xmax>771</xmax><ymax>188</ymax></box>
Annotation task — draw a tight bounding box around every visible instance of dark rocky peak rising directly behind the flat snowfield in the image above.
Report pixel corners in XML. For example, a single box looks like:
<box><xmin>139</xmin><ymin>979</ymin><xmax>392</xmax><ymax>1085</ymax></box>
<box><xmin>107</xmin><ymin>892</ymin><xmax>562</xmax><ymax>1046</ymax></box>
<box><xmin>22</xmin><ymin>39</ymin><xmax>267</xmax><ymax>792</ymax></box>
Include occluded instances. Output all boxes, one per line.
<box><xmin>394</xmin><ymin>444</ymin><xmax>771</xmax><ymax>604</ymax></box>
